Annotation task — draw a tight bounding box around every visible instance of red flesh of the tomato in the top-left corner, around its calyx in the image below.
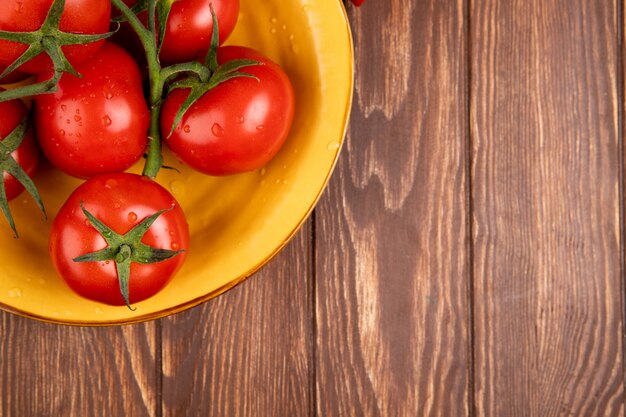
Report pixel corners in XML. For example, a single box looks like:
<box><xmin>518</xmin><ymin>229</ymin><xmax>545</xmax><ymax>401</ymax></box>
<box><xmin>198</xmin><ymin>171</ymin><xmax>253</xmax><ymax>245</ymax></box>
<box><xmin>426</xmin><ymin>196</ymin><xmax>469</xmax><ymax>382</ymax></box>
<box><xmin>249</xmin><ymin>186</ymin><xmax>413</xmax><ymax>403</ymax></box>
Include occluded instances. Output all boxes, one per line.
<box><xmin>0</xmin><ymin>0</ymin><xmax>111</xmax><ymax>74</ymax></box>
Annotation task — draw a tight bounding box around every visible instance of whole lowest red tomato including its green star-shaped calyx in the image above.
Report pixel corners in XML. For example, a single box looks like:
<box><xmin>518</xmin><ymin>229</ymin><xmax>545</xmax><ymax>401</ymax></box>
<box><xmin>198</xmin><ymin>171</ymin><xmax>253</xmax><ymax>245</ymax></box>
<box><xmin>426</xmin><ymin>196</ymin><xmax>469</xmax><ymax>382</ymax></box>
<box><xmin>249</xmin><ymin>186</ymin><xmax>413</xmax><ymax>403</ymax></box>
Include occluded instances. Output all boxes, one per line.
<box><xmin>49</xmin><ymin>173</ymin><xmax>189</xmax><ymax>307</ymax></box>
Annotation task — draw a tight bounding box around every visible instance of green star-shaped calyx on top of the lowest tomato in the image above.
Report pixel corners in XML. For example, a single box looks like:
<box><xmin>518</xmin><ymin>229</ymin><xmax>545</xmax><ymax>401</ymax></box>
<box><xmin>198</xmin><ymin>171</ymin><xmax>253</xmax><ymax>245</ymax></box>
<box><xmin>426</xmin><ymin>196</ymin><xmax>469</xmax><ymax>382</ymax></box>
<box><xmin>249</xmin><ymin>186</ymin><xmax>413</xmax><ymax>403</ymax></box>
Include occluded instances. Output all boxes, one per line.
<box><xmin>73</xmin><ymin>202</ymin><xmax>184</xmax><ymax>311</ymax></box>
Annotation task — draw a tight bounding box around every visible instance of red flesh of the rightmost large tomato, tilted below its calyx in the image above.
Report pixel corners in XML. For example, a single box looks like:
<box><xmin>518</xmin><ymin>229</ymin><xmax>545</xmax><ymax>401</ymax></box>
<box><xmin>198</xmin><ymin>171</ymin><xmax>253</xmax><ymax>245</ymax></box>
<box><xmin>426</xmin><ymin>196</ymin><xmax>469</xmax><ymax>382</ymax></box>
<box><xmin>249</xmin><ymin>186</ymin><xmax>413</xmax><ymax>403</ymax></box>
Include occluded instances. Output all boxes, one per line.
<box><xmin>161</xmin><ymin>46</ymin><xmax>294</xmax><ymax>175</ymax></box>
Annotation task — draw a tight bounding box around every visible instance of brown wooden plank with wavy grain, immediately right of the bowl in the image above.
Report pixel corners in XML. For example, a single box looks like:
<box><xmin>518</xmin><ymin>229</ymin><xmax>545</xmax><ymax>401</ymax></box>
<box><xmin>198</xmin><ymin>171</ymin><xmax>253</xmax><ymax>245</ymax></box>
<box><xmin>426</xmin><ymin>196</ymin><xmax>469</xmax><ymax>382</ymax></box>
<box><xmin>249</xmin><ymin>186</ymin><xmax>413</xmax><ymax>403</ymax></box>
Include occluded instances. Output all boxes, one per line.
<box><xmin>316</xmin><ymin>0</ymin><xmax>470</xmax><ymax>417</ymax></box>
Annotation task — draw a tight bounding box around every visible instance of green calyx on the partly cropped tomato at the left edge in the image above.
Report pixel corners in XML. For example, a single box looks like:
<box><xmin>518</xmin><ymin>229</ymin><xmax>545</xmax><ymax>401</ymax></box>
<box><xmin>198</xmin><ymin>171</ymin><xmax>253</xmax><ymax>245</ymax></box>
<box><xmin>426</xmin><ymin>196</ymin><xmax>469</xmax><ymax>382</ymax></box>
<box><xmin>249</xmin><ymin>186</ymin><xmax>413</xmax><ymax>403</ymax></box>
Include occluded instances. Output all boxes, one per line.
<box><xmin>0</xmin><ymin>114</ymin><xmax>46</xmax><ymax>238</ymax></box>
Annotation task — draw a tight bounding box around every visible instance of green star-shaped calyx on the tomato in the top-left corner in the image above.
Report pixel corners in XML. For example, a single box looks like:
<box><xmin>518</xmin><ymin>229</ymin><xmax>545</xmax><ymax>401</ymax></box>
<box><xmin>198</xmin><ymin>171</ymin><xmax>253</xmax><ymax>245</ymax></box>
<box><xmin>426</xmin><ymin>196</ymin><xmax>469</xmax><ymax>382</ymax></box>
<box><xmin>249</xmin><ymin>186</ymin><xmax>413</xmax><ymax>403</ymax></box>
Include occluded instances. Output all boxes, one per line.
<box><xmin>0</xmin><ymin>0</ymin><xmax>113</xmax><ymax>101</ymax></box>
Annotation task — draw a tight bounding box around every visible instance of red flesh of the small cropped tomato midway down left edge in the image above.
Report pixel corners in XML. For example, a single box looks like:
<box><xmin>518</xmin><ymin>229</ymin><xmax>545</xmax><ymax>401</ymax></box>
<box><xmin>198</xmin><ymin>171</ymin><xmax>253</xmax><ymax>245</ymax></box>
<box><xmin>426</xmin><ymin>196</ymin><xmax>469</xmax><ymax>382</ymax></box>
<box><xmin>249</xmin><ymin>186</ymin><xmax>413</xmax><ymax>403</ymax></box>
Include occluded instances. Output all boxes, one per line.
<box><xmin>0</xmin><ymin>94</ymin><xmax>39</xmax><ymax>200</ymax></box>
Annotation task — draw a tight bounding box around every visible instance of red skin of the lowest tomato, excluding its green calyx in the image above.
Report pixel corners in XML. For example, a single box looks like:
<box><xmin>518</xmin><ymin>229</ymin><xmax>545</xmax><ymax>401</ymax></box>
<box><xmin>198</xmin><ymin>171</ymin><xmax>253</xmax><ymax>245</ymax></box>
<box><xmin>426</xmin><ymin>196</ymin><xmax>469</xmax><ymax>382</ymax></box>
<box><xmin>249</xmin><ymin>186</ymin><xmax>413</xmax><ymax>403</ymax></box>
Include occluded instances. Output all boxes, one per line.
<box><xmin>49</xmin><ymin>173</ymin><xmax>189</xmax><ymax>305</ymax></box>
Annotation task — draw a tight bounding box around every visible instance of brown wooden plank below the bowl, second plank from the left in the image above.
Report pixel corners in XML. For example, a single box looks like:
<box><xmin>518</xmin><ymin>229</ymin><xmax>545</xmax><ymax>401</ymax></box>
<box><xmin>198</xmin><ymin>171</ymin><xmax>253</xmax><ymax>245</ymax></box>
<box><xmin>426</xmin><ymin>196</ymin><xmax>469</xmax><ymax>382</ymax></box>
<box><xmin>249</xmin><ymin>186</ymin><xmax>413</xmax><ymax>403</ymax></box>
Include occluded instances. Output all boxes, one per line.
<box><xmin>162</xmin><ymin>223</ymin><xmax>313</xmax><ymax>417</ymax></box>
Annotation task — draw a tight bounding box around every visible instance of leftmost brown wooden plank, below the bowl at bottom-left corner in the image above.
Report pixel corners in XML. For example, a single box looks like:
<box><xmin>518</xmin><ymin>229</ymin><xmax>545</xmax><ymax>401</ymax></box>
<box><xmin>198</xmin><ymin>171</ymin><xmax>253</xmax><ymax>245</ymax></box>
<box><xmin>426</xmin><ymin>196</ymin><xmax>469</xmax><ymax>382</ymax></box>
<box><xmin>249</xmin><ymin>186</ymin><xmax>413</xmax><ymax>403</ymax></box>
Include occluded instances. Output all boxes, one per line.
<box><xmin>0</xmin><ymin>312</ymin><xmax>159</xmax><ymax>417</ymax></box>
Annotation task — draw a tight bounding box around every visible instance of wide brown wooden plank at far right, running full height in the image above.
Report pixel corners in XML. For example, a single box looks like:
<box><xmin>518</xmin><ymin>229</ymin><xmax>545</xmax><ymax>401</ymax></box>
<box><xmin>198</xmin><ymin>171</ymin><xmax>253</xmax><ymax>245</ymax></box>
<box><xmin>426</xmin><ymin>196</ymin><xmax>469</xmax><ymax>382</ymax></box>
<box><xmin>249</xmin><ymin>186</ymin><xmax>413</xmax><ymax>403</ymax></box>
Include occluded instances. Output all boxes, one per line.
<box><xmin>470</xmin><ymin>0</ymin><xmax>624</xmax><ymax>417</ymax></box>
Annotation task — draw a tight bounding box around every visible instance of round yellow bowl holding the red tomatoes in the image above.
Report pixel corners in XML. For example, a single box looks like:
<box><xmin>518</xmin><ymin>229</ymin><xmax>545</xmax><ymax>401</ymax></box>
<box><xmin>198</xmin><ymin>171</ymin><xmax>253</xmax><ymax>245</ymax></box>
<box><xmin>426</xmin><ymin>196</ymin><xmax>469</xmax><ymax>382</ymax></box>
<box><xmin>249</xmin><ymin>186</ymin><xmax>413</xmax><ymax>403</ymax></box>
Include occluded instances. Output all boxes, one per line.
<box><xmin>0</xmin><ymin>0</ymin><xmax>353</xmax><ymax>325</ymax></box>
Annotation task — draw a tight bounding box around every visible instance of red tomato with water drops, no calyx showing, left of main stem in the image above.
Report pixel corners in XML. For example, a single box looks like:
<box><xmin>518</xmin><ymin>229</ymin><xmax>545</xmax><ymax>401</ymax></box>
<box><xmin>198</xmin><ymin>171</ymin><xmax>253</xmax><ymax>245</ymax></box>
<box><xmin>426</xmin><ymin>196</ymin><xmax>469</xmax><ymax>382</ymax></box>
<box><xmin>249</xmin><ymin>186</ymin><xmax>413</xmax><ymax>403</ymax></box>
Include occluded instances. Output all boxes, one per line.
<box><xmin>34</xmin><ymin>42</ymin><xmax>150</xmax><ymax>178</ymax></box>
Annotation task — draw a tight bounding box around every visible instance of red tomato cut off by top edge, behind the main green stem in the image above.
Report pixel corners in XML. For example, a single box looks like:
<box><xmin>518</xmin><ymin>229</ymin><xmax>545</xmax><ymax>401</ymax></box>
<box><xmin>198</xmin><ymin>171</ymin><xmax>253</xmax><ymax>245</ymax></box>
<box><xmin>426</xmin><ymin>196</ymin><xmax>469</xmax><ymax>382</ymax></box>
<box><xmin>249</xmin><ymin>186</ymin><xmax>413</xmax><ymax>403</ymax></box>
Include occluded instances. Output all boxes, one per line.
<box><xmin>115</xmin><ymin>0</ymin><xmax>239</xmax><ymax>65</ymax></box>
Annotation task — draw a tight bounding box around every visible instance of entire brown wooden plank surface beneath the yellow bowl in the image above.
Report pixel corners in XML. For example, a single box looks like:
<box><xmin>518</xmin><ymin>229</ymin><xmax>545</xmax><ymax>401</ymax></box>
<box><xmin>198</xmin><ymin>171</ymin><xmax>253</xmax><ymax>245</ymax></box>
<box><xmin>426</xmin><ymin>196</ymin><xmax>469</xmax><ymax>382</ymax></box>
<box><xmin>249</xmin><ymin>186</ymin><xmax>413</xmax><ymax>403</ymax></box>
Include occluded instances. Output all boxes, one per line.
<box><xmin>0</xmin><ymin>0</ymin><xmax>626</xmax><ymax>417</ymax></box>
